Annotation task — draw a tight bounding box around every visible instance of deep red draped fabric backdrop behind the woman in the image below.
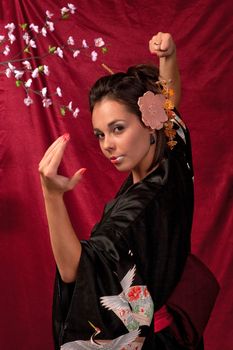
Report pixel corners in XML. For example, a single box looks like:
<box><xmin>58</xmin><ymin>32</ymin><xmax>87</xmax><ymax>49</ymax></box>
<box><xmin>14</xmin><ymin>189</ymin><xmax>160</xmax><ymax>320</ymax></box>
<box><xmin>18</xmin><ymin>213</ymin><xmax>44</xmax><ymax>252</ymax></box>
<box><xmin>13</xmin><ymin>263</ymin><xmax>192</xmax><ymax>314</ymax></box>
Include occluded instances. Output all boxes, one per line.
<box><xmin>0</xmin><ymin>0</ymin><xmax>233</xmax><ymax>350</ymax></box>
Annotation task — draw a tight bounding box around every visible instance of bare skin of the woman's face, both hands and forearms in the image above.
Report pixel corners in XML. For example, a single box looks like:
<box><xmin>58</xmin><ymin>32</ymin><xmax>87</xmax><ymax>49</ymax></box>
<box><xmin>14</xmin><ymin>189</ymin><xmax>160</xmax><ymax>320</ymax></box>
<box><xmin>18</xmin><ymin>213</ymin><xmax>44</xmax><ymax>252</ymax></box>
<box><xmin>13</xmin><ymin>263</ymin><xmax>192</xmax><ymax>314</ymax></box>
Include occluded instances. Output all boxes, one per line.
<box><xmin>39</xmin><ymin>32</ymin><xmax>180</xmax><ymax>283</ymax></box>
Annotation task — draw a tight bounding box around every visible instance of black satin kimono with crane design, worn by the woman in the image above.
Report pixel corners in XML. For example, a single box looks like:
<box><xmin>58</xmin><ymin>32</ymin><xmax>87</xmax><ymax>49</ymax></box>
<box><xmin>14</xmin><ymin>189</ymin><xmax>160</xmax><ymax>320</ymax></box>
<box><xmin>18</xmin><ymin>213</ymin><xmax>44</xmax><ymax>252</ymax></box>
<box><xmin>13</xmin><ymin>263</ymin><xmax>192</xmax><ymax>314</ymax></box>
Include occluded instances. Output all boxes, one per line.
<box><xmin>53</xmin><ymin>117</ymin><xmax>201</xmax><ymax>350</ymax></box>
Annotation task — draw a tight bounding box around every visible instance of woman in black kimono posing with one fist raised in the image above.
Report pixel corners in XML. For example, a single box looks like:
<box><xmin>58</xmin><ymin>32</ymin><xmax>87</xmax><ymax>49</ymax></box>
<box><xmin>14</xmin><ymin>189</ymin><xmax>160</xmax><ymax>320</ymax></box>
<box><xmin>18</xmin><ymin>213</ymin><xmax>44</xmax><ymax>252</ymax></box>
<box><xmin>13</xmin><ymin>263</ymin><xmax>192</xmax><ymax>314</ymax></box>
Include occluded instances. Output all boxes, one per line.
<box><xmin>39</xmin><ymin>33</ymin><xmax>213</xmax><ymax>350</ymax></box>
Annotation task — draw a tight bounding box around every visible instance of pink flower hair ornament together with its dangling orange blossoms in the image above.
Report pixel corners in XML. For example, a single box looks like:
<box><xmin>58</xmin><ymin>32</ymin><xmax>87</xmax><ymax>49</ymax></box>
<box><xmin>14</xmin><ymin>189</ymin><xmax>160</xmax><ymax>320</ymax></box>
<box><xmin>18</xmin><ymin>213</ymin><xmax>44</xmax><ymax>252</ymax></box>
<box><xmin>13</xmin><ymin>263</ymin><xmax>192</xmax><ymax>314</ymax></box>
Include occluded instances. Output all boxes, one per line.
<box><xmin>138</xmin><ymin>80</ymin><xmax>177</xmax><ymax>149</ymax></box>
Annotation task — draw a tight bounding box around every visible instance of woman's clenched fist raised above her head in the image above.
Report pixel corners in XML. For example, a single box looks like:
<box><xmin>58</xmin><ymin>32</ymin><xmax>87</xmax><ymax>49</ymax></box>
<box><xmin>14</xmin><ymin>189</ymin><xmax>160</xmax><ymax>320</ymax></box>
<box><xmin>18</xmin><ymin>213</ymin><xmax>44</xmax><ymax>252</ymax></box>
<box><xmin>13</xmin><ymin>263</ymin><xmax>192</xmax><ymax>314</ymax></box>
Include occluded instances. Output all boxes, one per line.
<box><xmin>149</xmin><ymin>32</ymin><xmax>176</xmax><ymax>58</ymax></box>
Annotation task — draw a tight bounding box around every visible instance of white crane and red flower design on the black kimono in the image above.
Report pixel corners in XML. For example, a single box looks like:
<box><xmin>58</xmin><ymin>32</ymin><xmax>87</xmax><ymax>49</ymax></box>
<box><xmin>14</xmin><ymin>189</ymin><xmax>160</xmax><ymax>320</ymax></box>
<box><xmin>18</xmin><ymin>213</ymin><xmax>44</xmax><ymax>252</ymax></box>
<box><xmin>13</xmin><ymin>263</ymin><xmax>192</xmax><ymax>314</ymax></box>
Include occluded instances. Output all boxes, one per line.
<box><xmin>61</xmin><ymin>265</ymin><xmax>154</xmax><ymax>350</ymax></box>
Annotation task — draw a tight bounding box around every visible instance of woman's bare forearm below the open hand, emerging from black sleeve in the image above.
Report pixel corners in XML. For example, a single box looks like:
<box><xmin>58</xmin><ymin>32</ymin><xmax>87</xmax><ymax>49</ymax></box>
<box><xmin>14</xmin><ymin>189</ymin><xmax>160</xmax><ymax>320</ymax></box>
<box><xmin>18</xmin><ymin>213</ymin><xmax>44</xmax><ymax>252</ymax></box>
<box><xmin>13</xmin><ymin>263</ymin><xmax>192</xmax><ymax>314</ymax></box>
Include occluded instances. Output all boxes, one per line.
<box><xmin>44</xmin><ymin>195</ymin><xmax>81</xmax><ymax>282</ymax></box>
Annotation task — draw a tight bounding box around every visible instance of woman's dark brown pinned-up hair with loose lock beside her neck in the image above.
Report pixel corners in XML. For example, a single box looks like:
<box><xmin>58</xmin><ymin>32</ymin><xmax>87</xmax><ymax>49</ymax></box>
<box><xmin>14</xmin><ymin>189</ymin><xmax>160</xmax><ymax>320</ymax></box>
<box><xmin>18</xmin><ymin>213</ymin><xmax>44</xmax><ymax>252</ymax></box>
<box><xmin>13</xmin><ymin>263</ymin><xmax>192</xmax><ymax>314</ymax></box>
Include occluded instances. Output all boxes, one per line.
<box><xmin>89</xmin><ymin>64</ymin><xmax>167</xmax><ymax>170</ymax></box>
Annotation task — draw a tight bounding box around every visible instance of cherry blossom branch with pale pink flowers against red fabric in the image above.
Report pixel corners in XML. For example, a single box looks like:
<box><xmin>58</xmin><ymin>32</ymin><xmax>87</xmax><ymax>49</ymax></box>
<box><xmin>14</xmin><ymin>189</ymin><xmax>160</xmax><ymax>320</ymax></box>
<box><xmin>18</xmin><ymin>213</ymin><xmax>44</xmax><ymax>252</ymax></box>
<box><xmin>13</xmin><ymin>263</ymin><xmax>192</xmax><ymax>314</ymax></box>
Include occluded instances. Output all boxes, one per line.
<box><xmin>0</xmin><ymin>3</ymin><xmax>108</xmax><ymax>117</ymax></box>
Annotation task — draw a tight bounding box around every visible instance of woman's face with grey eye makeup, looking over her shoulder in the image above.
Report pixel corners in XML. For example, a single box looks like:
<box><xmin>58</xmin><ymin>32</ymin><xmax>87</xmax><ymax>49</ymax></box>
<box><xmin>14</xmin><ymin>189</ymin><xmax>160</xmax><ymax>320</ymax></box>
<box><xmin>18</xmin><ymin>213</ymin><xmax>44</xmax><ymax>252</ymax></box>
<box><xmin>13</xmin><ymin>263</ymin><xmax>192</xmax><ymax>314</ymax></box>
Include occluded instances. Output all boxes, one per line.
<box><xmin>92</xmin><ymin>98</ymin><xmax>155</xmax><ymax>182</ymax></box>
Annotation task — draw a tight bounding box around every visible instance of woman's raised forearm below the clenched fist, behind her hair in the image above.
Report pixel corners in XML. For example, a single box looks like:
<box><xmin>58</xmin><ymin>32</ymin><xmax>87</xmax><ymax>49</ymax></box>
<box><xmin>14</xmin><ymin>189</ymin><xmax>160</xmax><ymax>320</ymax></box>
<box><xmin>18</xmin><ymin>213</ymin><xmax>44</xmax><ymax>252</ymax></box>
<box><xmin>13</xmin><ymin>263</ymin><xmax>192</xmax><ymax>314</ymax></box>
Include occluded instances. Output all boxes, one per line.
<box><xmin>159</xmin><ymin>50</ymin><xmax>181</xmax><ymax>107</ymax></box>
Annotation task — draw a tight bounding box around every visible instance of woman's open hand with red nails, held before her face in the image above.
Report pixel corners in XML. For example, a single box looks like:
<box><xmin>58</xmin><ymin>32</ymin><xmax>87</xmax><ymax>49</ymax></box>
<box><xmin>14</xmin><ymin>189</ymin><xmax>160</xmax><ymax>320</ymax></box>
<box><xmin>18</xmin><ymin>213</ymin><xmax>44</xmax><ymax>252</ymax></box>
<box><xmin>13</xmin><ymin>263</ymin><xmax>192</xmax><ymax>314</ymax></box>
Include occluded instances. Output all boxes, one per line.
<box><xmin>39</xmin><ymin>134</ymin><xmax>86</xmax><ymax>195</ymax></box>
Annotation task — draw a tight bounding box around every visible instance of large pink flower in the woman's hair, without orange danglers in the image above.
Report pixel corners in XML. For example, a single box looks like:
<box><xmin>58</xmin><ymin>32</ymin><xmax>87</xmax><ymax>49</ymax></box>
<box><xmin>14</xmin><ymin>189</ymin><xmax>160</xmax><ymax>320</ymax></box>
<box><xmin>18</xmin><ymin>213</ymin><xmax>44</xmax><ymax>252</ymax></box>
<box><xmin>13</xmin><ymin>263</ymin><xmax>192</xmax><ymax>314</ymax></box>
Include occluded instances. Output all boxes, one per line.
<box><xmin>138</xmin><ymin>91</ymin><xmax>168</xmax><ymax>130</ymax></box>
